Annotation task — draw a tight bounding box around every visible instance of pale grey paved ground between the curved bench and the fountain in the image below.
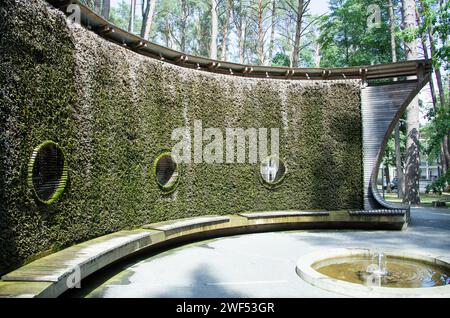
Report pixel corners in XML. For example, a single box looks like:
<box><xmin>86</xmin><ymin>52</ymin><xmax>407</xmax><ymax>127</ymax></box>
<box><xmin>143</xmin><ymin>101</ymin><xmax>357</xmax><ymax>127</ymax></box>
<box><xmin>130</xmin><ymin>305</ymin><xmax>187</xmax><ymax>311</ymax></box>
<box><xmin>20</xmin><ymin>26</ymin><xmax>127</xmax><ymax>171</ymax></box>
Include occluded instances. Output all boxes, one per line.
<box><xmin>72</xmin><ymin>208</ymin><xmax>450</xmax><ymax>297</ymax></box>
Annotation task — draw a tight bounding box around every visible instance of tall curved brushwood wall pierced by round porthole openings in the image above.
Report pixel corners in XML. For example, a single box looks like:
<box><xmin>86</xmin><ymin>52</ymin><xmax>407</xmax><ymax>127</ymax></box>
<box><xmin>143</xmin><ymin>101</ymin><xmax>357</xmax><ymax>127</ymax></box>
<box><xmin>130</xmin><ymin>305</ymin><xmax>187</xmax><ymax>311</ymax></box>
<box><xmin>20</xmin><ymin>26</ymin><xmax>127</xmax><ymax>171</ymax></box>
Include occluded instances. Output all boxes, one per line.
<box><xmin>0</xmin><ymin>0</ymin><xmax>363</xmax><ymax>272</ymax></box>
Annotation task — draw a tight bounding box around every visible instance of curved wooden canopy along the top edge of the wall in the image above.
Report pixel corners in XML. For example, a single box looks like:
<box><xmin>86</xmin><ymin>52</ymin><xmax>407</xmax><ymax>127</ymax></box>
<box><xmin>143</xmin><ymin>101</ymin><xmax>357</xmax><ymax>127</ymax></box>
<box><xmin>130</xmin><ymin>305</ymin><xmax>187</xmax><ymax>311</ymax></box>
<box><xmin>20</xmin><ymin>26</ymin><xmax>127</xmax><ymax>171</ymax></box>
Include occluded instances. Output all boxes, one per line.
<box><xmin>48</xmin><ymin>0</ymin><xmax>432</xmax><ymax>82</ymax></box>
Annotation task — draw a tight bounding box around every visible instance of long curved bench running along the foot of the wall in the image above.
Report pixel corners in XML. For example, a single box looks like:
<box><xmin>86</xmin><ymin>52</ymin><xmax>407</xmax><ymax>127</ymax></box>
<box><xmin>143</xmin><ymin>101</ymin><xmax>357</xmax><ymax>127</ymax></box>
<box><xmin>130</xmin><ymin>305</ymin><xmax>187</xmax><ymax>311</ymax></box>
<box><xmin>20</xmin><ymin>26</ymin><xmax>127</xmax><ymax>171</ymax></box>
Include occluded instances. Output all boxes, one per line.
<box><xmin>0</xmin><ymin>211</ymin><xmax>405</xmax><ymax>297</ymax></box>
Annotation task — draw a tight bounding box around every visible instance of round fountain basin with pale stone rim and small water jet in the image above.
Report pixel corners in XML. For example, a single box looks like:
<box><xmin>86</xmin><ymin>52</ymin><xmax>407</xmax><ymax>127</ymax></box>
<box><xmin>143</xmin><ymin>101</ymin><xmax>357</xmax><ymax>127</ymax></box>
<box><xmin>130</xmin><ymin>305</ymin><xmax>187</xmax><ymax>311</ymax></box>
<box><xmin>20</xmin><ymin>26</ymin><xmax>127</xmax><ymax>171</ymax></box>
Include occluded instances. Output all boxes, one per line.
<box><xmin>296</xmin><ymin>248</ymin><xmax>450</xmax><ymax>297</ymax></box>
